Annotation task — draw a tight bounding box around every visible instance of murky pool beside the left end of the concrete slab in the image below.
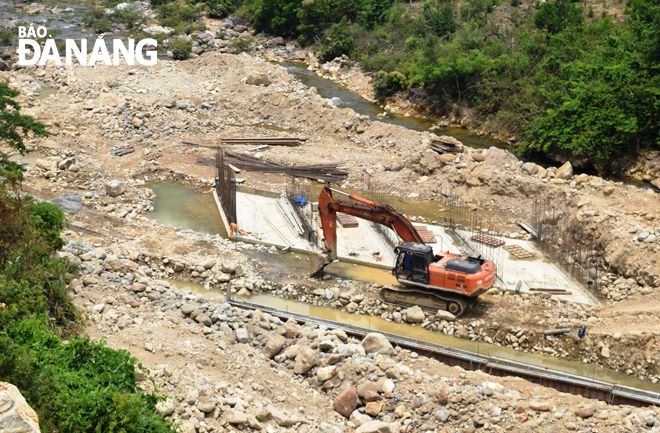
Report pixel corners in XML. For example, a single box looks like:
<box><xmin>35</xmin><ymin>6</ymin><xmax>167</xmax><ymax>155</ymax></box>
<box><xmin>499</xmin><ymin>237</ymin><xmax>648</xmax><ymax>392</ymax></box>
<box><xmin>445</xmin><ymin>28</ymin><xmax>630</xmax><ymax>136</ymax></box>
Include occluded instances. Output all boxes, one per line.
<box><xmin>146</xmin><ymin>182</ymin><xmax>227</xmax><ymax>237</ymax></box>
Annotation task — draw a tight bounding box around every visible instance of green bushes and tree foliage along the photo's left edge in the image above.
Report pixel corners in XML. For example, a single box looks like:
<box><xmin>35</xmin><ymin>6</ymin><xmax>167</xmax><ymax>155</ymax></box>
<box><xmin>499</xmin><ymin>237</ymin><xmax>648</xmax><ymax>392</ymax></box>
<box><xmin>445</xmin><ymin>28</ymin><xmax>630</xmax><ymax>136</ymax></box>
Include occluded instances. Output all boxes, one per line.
<box><xmin>0</xmin><ymin>83</ymin><xmax>175</xmax><ymax>433</ymax></box>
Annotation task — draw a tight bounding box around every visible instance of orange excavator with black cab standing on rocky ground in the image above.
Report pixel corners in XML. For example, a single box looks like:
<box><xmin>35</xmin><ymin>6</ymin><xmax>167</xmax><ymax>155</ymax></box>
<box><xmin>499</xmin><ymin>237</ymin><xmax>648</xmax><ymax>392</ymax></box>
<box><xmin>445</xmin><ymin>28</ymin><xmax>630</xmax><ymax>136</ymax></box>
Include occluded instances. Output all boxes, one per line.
<box><xmin>309</xmin><ymin>186</ymin><xmax>496</xmax><ymax>316</ymax></box>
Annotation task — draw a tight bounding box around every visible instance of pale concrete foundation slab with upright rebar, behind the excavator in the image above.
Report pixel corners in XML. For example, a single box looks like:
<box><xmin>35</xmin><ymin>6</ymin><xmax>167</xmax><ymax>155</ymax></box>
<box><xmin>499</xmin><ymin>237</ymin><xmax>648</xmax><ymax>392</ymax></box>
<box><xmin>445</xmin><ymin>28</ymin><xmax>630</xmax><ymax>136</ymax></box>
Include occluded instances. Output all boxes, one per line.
<box><xmin>221</xmin><ymin>188</ymin><xmax>598</xmax><ymax>304</ymax></box>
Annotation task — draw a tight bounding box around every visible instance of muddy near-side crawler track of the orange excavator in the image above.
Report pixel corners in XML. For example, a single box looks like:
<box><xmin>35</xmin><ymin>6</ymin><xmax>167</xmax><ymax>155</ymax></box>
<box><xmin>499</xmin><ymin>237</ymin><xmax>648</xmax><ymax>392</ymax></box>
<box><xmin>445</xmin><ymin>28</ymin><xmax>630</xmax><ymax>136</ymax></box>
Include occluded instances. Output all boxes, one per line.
<box><xmin>380</xmin><ymin>286</ymin><xmax>467</xmax><ymax>317</ymax></box>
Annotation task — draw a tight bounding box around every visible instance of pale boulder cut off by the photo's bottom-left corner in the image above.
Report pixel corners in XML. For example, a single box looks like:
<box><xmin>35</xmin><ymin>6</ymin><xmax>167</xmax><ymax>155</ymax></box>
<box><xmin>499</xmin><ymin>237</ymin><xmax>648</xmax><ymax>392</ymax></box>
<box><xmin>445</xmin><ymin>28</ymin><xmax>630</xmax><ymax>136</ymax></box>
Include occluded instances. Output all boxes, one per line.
<box><xmin>0</xmin><ymin>382</ymin><xmax>41</xmax><ymax>433</ymax></box>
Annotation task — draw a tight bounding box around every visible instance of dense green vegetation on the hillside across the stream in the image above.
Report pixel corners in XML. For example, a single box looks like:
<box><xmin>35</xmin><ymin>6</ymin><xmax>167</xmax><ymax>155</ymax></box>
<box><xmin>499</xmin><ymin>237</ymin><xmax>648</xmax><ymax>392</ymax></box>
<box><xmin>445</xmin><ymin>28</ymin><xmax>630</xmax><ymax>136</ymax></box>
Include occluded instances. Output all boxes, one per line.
<box><xmin>236</xmin><ymin>0</ymin><xmax>660</xmax><ymax>165</ymax></box>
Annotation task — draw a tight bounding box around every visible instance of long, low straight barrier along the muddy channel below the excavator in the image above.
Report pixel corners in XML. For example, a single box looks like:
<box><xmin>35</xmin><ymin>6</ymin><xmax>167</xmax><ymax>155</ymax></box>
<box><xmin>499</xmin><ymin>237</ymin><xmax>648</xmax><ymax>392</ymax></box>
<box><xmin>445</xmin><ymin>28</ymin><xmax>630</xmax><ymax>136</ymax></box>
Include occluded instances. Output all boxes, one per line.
<box><xmin>227</xmin><ymin>299</ymin><xmax>660</xmax><ymax>406</ymax></box>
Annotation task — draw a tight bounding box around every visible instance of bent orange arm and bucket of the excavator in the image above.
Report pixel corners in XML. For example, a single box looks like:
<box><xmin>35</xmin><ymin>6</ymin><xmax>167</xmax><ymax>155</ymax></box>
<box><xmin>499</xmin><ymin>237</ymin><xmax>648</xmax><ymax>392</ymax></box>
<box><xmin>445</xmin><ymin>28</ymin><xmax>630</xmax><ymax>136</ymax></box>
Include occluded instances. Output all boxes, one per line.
<box><xmin>310</xmin><ymin>186</ymin><xmax>424</xmax><ymax>274</ymax></box>
